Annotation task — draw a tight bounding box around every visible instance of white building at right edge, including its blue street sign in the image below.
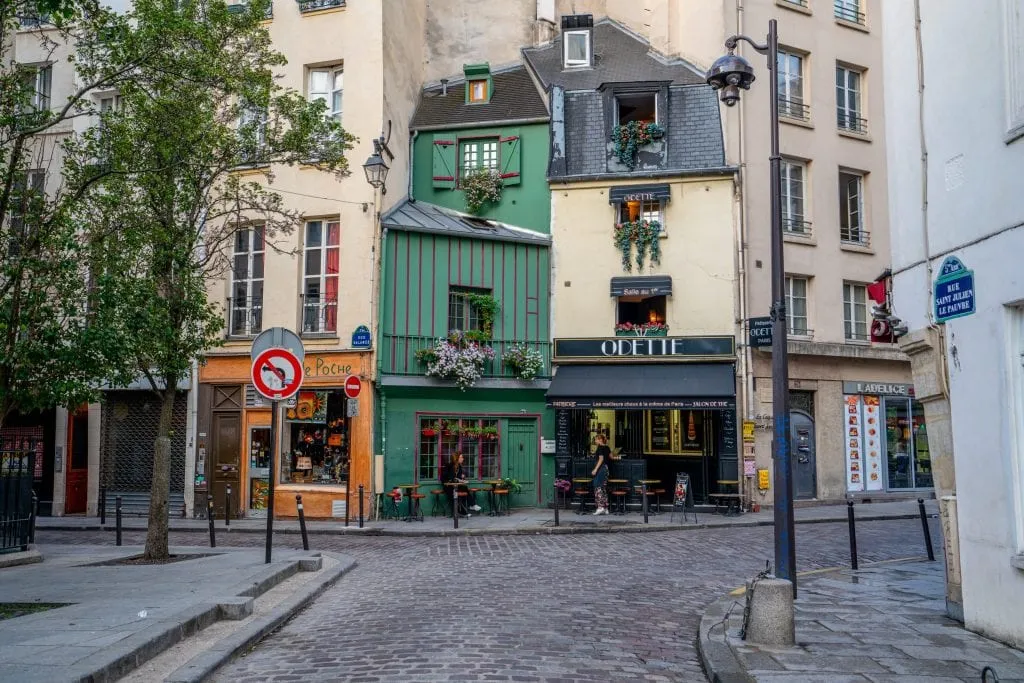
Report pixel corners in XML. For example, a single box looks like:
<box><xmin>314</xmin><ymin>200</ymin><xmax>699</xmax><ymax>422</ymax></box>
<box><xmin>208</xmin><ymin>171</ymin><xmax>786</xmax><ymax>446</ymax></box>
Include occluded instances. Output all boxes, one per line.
<box><xmin>884</xmin><ymin>0</ymin><xmax>1024</xmax><ymax>647</ymax></box>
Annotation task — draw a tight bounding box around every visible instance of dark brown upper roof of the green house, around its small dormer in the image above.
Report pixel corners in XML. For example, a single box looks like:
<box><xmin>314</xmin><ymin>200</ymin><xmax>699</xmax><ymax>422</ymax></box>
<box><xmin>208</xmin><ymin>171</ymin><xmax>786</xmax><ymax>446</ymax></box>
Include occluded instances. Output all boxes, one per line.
<box><xmin>410</xmin><ymin>66</ymin><xmax>548</xmax><ymax>130</ymax></box>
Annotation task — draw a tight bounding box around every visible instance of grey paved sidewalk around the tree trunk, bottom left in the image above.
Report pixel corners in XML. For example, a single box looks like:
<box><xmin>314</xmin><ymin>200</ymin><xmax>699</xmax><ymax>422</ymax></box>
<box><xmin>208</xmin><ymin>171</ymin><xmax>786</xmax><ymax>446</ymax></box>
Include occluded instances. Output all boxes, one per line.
<box><xmin>0</xmin><ymin>545</ymin><xmax>353</xmax><ymax>683</ymax></box>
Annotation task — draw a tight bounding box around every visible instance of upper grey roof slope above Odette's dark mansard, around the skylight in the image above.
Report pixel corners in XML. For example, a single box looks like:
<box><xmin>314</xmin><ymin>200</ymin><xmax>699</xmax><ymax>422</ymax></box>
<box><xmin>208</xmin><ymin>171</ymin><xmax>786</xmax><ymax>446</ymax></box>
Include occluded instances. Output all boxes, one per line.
<box><xmin>524</xmin><ymin>18</ymin><xmax>705</xmax><ymax>92</ymax></box>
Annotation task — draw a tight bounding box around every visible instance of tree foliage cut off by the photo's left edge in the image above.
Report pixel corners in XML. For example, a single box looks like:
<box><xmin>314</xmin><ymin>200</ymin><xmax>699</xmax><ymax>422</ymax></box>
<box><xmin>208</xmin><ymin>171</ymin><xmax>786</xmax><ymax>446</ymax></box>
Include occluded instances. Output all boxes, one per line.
<box><xmin>0</xmin><ymin>0</ymin><xmax>156</xmax><ymax>426</ymax></box>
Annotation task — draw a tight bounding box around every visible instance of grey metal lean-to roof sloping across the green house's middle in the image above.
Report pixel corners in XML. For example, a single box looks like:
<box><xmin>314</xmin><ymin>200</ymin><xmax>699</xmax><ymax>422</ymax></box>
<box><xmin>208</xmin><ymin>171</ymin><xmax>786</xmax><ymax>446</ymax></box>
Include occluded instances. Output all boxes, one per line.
<box><xmin>383</xmin><ymin>200</ymin><xmax>551</xmax><ymax>245</ymax></box>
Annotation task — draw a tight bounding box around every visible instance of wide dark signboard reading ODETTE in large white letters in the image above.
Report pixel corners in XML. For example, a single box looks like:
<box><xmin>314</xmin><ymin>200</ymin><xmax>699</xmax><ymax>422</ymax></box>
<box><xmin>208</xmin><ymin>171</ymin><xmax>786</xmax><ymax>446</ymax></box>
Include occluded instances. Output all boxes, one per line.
<box><xmin>554</xmin><ymin>337</ymin><xmax>736</xmax><ymax>362</ymax></box>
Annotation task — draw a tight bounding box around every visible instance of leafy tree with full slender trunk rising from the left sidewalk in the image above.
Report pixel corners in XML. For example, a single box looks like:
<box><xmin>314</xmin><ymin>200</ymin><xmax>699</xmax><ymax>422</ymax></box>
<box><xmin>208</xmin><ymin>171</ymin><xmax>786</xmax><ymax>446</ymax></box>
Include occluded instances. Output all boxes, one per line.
<box><xmin>72</xmin><ymin>0</ymin><xmax>352</xmax><ymax>559</ymax></box>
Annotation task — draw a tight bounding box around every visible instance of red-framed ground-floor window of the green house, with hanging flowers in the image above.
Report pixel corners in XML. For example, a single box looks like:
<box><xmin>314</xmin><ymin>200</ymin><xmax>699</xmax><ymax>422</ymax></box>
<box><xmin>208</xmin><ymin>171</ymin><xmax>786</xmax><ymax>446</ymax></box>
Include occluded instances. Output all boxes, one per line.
<box><xmin>418</xmin><ymin>417</ymin><xmax>502</xmax><ymax>480</ymax></box>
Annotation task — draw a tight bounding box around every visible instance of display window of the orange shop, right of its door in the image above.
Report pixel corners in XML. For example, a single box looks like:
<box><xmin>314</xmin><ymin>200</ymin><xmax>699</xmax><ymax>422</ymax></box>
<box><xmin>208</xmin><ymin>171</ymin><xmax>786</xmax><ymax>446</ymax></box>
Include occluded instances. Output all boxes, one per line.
<box><xmin>281</xmin><ymin>389</ymin><xmax>349</xmax><ymax>485</ymax></box>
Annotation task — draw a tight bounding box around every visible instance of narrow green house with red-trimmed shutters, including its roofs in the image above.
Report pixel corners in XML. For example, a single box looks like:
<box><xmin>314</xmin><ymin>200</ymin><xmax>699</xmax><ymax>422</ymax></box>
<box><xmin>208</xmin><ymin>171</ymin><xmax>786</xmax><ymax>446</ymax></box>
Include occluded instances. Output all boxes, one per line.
<box><xmin>377</xmin><ymin>65</ymin><xmax>554</xmax><ymax>513</ymax></box>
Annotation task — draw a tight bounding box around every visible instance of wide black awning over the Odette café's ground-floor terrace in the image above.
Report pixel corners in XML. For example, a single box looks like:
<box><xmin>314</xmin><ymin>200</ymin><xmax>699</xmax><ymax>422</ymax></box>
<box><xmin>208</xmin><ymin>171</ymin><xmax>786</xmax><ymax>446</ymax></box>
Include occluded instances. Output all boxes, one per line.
<box><xmin>546</xmin><ymin>362</ymin><xmax>736</xmax><ymax>410</ymax></box>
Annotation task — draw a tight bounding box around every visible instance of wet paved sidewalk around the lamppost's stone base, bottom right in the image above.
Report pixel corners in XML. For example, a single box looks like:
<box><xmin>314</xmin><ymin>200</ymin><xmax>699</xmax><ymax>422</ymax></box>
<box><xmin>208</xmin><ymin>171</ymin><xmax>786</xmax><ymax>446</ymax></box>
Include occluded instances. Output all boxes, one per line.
<box><xmin>699</xmin><ymin>559</ymin><xmax>1024</xmax><ymax>683</ymax></box>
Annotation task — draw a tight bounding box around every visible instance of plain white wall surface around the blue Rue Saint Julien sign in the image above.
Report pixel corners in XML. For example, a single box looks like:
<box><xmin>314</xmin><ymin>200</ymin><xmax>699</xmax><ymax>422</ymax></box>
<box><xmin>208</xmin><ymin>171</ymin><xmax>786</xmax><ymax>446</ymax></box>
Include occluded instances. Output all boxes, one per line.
<box><xmin>883</xmin><ymin>0</ymin><xmax>1024</xmax><ymax>647</ymax></box>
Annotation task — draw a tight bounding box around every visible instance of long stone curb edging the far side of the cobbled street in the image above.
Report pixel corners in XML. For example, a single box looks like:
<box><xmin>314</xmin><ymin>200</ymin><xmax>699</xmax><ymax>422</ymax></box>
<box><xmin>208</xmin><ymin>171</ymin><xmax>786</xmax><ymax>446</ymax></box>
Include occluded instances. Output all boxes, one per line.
<box><xmin>36</xmin><ymin>513</ymin><xmax>937</xmax><ymax>538</ymax></box>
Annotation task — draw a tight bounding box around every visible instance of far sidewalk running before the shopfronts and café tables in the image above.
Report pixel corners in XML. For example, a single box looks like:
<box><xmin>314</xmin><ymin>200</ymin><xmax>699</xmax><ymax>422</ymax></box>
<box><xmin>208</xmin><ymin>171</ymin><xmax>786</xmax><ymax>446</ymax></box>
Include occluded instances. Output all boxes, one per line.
<box><xmin>37</xmin><ymin>500</ymin><xmax>938</xmax><ymax>536</ymax></box>
